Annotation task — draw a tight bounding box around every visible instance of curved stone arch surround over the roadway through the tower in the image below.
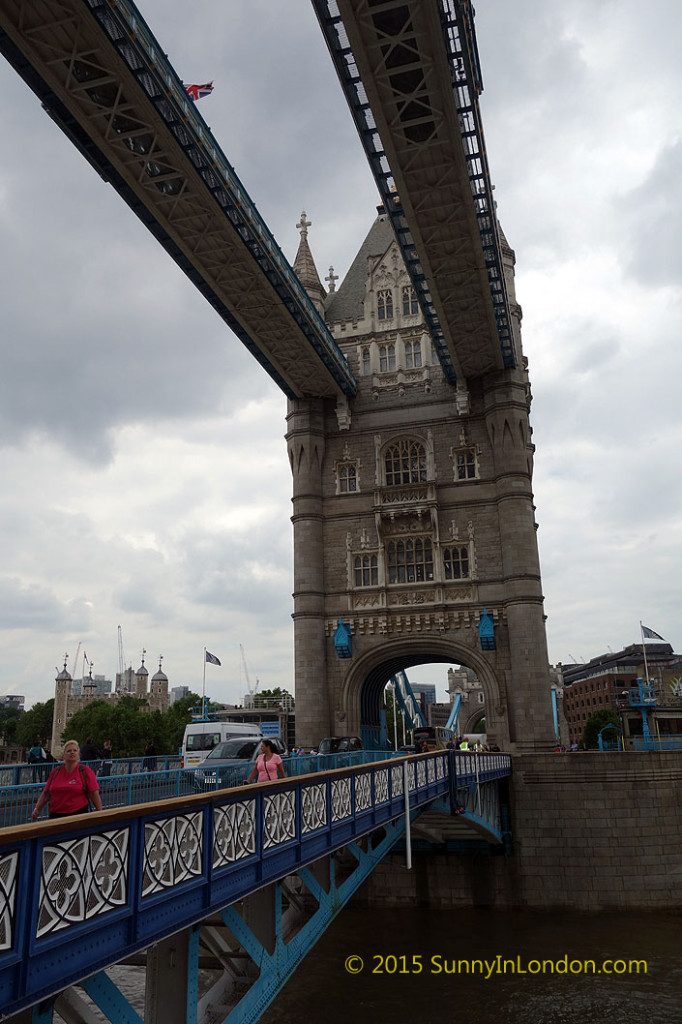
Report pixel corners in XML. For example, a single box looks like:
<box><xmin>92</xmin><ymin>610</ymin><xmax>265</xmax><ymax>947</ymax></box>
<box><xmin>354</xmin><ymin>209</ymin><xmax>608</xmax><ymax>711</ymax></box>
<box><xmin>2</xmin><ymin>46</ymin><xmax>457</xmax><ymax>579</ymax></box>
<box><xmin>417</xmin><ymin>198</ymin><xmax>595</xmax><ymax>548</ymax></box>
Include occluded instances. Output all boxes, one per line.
<box><xmin>337</xmin><ymin>639</ymin><xmax>509</xmax><ymax>748</ymax></box>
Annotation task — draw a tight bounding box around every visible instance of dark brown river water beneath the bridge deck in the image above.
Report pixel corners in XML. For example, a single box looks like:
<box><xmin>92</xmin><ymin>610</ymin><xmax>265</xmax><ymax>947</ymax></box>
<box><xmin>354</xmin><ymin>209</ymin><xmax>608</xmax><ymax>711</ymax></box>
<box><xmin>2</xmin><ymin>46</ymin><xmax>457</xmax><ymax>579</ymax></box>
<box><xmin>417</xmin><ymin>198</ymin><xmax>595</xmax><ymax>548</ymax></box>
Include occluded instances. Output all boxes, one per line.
<box><xmin>96</xmin><ymin>907</ymin><xmax>682</xmax><ymax>1024</ymax></box>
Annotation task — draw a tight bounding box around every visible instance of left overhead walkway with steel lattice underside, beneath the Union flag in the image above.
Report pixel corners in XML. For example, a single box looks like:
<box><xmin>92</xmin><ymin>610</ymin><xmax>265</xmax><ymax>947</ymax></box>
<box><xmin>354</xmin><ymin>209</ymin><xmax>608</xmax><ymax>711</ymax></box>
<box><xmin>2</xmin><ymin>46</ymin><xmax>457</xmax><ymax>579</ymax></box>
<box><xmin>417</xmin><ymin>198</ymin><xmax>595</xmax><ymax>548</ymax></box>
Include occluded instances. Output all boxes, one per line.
<box><xmin>0</xmin><ymin>0</ymin><xmax>355</xmax><ymax>398</ymax></box>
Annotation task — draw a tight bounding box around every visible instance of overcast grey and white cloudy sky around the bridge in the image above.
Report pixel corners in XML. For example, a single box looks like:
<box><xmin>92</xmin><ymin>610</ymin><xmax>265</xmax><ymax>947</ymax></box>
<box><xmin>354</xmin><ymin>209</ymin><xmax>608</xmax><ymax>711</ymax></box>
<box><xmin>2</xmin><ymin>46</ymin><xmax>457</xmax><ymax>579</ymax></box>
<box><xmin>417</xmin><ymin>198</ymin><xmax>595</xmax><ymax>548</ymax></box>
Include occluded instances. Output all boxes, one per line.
<box><xmin>0</xmin><ymin>0</ymin><xmax>682</xmax><ymax>707</ymax></box>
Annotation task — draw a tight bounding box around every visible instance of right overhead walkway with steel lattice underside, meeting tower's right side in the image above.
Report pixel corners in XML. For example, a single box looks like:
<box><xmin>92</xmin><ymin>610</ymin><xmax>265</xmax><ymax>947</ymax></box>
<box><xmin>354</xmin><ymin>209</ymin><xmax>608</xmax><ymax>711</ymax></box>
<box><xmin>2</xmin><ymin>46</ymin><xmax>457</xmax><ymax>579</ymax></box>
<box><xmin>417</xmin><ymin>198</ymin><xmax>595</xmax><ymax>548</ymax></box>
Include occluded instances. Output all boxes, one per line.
<box><xmin>312</xmin><ymin>0</ymin><xmax>519</xmax><ymax>382</ymax></box>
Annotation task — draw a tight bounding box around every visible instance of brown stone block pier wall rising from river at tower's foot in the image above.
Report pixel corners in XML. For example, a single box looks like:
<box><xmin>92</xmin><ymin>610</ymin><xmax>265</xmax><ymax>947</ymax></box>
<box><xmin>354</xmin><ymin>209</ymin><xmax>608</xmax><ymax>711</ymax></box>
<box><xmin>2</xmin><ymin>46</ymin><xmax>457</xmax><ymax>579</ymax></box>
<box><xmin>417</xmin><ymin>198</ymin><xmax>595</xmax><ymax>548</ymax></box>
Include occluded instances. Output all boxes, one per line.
<box><xmin>357</xmin><ymin>752</ymin><xmax>682</xmax><ymax>910</ymax></box>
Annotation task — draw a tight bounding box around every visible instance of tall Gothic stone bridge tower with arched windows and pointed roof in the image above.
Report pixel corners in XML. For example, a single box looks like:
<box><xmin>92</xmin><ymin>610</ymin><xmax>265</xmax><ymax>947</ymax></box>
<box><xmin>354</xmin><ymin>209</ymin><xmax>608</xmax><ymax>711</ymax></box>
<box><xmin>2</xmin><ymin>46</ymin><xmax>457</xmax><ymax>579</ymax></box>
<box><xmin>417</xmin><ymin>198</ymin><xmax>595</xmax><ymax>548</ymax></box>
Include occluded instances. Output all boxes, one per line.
<box><xmin>287</xmin><ymin>207</ymin><xmax>553</xmax><ymax>752</ymax></box>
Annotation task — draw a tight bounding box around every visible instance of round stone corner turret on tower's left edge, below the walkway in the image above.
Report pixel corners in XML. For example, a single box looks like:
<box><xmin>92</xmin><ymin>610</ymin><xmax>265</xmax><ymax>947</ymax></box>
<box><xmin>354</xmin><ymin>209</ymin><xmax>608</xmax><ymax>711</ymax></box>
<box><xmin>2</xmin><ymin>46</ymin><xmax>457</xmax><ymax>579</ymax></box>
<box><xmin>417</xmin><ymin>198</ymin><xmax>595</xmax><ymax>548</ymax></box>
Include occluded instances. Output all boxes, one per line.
<box><xmin>287</xmin><ymin>398</ymin><xmax>331</xmax><ymax>746</ymax></box>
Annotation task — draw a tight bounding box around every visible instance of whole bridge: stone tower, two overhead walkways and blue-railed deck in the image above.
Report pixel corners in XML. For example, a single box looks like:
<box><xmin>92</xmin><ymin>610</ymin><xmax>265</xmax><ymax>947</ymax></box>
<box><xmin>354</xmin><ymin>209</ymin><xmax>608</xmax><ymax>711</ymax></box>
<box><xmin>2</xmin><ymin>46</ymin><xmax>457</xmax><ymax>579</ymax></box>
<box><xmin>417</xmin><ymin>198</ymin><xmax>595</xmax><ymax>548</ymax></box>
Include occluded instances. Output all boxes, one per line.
<box><xmin>0</xmin><ymin>0</ymin><xmax>553</xmax><ymax>1024</ymax></box>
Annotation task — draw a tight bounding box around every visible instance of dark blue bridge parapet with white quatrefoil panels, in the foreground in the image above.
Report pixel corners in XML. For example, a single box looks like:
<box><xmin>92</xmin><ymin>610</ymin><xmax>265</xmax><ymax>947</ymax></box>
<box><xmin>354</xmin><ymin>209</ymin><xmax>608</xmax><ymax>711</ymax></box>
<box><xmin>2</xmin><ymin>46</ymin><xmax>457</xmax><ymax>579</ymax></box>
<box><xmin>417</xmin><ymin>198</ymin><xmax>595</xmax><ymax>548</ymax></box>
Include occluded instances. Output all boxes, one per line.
<box><xmin>0</xmin><ymin>751</ymin><xmax>511</xmax><ymax>1014</ymax></box>
